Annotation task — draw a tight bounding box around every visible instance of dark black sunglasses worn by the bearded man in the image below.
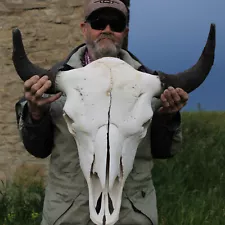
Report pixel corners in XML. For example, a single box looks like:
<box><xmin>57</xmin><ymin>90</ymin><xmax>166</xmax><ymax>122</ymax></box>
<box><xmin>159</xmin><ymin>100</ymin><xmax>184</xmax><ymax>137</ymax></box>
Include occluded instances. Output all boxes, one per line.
<box><xmin>86</xmin><ymin>18</ymin><xmax>126</xmax><ymax>33</ymax></box>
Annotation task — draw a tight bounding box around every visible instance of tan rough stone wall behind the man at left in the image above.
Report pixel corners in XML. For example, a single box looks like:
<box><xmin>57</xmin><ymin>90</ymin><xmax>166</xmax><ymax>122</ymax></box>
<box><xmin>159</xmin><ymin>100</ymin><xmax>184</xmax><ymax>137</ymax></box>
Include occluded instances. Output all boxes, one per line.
<box><xmin>0</xmin><ymin>0</ymin><xmax>83</xmax><ymax>181</ymax></box>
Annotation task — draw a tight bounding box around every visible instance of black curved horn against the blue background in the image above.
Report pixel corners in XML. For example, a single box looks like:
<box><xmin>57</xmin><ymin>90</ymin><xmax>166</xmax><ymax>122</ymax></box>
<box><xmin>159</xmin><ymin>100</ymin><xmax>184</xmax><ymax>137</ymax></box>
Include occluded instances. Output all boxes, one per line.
<box><xmin>158</xmin><ymin>24</ymin><xmax>216</xmax><ymax>93</ymax></box>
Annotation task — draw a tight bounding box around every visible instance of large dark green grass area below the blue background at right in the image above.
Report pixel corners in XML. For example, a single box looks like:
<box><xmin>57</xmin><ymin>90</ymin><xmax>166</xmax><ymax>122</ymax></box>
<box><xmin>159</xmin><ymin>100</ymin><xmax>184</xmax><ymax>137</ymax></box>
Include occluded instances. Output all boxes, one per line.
<box><xmin>153</xmin><ymin>112</ymin><xmax>225</xmax><ymax>225</ymax></box>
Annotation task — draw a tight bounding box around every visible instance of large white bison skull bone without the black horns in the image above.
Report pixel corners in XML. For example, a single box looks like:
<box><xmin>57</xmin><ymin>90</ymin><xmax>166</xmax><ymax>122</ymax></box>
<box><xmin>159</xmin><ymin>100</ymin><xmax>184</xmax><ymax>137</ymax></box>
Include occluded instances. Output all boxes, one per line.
<box><xmin>56</xmin><ymin>58</ymin><xmax>162</xmax><ymax>225</ymax></box>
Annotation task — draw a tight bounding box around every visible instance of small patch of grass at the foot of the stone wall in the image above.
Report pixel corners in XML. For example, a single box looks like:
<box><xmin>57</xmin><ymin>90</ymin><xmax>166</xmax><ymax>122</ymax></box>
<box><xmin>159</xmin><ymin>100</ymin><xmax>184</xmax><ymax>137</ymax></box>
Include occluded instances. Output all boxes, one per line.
<box><xmin>0</xmin><ymin>174</ymin><xmax>44</xmax><ymax>225</ymax></box>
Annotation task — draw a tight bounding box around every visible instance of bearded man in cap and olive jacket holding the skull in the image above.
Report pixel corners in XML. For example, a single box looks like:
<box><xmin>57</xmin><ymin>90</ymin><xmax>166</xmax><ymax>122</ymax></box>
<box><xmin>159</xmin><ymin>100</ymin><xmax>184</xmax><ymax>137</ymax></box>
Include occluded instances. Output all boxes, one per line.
<box><xmin>16</xmin><ymin>0</ymin><xmax>188</xmax><ymax>225</ymax></box>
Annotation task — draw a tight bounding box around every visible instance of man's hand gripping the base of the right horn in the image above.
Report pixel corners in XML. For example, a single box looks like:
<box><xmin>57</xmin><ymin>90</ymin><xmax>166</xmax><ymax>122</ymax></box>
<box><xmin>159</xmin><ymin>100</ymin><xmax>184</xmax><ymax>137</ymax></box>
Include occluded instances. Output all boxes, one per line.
<box><xmin>159</xmin><ymin>87</ymin><xmax>188</xmax><ymax>114</ymax></box>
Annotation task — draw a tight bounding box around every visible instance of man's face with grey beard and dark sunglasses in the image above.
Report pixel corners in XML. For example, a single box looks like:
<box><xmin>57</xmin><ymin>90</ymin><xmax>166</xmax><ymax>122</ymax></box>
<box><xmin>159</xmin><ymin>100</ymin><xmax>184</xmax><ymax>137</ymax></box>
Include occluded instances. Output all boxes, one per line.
<box><xmin>81</xmin><ymin>9</ymin><xmax>128</xmax><ymax>60</ymax></box>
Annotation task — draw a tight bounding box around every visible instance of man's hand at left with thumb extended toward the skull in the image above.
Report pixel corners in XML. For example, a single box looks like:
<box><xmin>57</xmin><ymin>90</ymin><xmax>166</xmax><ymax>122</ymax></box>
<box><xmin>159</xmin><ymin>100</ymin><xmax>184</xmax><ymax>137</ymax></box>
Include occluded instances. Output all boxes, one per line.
<box><xmin>24</xmin><ymin>75</ymin><xmax>61</xmax><ymax>120</ymax></box>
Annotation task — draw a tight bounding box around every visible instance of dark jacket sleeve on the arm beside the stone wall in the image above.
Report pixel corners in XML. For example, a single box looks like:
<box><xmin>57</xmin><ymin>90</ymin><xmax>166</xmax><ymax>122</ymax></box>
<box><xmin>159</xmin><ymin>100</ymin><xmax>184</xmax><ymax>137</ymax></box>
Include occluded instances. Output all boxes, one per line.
<box><xmin>15</xmin><ymin>98</ymin><xmax>53</xmax><ymax>158</ymax></box>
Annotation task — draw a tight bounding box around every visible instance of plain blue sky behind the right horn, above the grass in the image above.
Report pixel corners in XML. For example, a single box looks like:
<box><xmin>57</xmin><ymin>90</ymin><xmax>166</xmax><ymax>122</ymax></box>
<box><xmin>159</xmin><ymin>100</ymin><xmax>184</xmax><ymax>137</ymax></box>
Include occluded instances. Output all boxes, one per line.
<box><xmin>128</xmin><ymin>0</ymin><xmax>225</xmax><ymax>111</ymax></box>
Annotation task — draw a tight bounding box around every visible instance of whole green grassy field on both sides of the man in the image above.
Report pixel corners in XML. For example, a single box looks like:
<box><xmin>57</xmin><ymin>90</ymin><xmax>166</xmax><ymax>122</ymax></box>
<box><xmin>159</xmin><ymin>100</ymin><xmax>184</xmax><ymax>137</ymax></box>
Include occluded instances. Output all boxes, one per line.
<box><xmin>0</xmin><ymin>112</ymin><xmax>225</xmax><ymax>225</ymax></box>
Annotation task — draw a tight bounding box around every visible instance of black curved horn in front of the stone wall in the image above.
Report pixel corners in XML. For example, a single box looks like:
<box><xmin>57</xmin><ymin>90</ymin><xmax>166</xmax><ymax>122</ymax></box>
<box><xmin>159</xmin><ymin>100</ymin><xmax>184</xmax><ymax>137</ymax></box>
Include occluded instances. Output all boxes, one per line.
<box><xmin>12</xmin><ymin>28</ymin><xmax>56</xmax><ymax>93</ymax></box>
